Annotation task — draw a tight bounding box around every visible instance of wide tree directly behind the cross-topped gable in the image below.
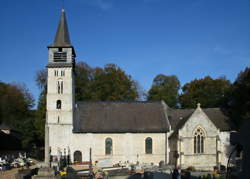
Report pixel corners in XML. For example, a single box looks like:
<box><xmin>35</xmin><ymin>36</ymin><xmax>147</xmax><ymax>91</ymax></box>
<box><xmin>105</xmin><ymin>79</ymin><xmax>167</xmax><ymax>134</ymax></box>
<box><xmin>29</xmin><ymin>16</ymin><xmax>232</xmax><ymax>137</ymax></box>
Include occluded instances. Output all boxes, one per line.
<box><xmin>180</xmin><ymin>76</ymin><xmax>231</xmax><ymax>108</ymax></box>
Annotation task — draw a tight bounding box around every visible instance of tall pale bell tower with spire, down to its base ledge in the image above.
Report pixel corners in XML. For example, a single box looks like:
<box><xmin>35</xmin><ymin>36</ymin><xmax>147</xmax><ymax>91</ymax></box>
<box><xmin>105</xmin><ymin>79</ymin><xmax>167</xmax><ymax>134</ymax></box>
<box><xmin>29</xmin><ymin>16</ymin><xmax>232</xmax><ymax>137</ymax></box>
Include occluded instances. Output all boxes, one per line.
<box><xmin>47</xmin><ymin>9</ymin><xmax>76</xmax><ymax>127</ymax></box>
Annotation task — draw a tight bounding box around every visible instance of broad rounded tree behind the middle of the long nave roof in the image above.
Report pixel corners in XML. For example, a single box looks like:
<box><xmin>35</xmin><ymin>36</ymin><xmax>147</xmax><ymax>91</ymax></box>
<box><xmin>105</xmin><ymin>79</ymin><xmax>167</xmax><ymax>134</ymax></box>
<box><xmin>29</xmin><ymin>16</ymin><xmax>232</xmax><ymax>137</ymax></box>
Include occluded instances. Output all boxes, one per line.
<box><xmin>90</xmin><ymin>64</ymin><xmax>138</xmax><ymax>101</ymax></box>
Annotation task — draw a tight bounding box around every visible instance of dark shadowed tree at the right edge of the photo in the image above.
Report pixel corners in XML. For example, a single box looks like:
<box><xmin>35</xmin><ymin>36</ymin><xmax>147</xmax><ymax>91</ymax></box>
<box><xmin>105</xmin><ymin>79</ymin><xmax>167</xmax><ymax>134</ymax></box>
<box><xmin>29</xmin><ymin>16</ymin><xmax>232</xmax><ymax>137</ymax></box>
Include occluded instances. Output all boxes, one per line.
<box><xmin>224</xmin><ymin>67</ymin><xmax>250</xmax><ymax>128</ymax></box>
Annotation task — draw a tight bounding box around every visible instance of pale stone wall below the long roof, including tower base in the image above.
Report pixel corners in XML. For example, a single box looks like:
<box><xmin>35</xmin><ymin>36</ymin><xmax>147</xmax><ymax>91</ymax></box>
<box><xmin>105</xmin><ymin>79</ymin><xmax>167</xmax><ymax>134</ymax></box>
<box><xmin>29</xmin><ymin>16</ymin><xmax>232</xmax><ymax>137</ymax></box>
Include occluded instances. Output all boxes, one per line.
<box><xmin>49</xmin><ymin>125</ymin><xmax>167</xmax><ymax>164</ymax></box>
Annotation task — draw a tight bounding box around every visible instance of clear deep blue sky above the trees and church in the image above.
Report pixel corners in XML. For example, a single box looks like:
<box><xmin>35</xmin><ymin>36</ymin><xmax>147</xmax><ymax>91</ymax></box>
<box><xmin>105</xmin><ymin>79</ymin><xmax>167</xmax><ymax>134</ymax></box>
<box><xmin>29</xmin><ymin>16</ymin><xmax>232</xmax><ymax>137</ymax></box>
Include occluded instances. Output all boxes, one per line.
<box><xmin>0</xmin><ymin>0</ymin><xmax>250</xmax><ymax>106</ymax></box>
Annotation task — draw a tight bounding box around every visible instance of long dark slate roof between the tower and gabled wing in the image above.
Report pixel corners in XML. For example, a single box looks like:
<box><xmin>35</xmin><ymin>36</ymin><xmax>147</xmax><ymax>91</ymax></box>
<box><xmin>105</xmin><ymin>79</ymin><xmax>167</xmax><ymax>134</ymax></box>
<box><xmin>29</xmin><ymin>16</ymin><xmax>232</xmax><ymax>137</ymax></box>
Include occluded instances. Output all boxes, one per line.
<box><xmin>73</xmin><ymin>101</ymin><xmax>169</xmax><ymax>133</ymax></box>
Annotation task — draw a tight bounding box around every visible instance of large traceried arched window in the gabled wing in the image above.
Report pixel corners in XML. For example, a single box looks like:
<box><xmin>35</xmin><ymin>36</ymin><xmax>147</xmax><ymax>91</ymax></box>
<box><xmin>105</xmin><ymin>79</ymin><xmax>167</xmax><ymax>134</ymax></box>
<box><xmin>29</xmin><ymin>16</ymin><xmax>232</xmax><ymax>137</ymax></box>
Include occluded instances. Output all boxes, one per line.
<box><xmin>194</xmin><ymin>128</ymin><xmax>205</xmax><ymax>154</ymax></box>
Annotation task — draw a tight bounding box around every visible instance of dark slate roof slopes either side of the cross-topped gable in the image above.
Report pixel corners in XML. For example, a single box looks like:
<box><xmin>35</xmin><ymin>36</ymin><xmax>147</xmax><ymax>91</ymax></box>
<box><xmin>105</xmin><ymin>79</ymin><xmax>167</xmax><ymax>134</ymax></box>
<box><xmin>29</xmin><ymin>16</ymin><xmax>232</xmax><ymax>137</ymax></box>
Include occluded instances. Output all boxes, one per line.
<box><xmin>168</xmin><ymin>108</ymin><xmax>232</xmax><ymax>137</ymax></box>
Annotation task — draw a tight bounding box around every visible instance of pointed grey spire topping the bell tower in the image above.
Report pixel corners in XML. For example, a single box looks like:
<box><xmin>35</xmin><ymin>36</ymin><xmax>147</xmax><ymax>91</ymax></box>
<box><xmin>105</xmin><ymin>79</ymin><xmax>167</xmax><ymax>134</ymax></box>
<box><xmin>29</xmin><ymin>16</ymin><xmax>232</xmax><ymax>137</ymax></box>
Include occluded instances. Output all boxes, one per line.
<box><xmin>52</xmin><ymin>9</ymin><xmax>71</xmax><ymax>47</ymax></box>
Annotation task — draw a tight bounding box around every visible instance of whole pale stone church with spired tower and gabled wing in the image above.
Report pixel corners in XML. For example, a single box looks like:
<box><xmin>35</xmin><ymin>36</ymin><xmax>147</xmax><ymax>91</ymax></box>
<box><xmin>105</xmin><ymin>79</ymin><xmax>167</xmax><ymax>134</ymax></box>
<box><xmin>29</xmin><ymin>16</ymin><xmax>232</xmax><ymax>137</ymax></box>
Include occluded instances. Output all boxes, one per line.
<box><xmin>46</xmin><ymin>10</ymin><xmax>231</xmax><ymax>169</ymax></box>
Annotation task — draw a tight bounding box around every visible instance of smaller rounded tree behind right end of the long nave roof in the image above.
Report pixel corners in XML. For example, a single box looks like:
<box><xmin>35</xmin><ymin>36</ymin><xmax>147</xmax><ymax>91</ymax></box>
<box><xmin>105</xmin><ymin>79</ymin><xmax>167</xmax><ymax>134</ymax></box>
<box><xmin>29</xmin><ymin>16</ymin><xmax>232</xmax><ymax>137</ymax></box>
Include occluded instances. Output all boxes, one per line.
<box><xmin>148</xmin><ymin>74</ymin><xmax>180</xmax><ymax>108</ymax></box>
